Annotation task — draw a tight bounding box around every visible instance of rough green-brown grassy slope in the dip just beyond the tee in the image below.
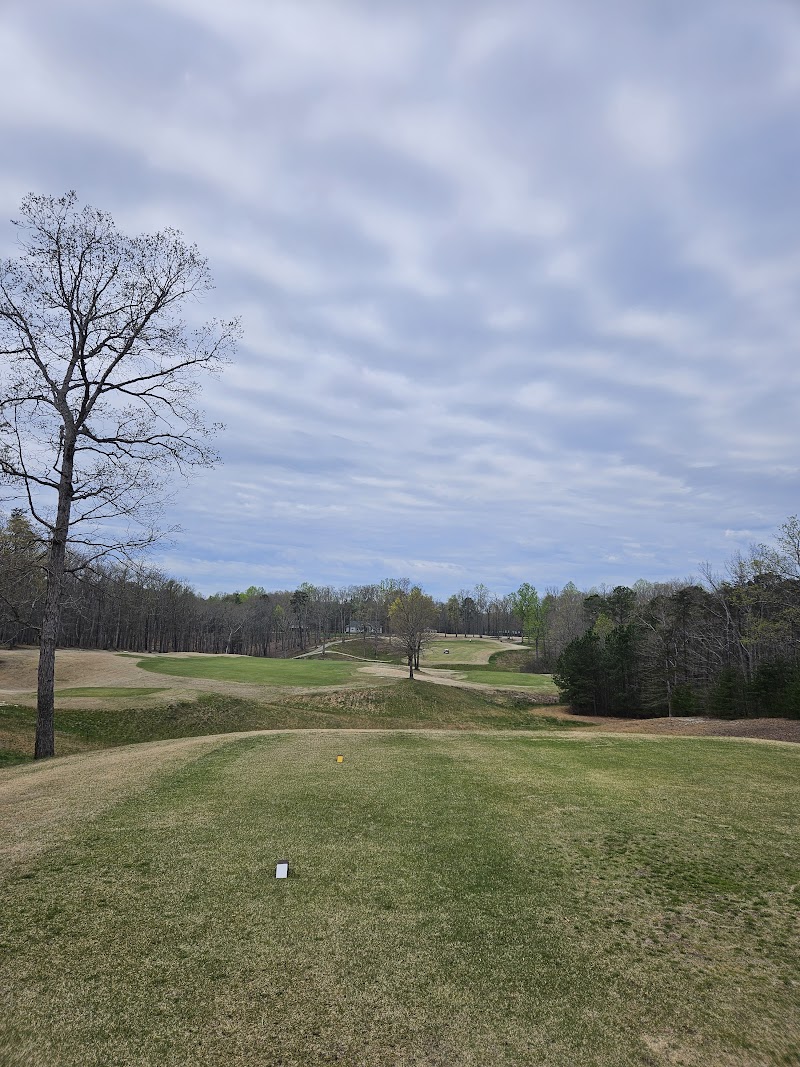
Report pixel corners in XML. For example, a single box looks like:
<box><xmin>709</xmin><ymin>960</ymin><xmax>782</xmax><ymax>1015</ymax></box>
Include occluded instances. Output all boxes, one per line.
<box><xmin>0</xmin><ymin>680</ymin><xmax>582</xmax><ymax>762</ymax></box>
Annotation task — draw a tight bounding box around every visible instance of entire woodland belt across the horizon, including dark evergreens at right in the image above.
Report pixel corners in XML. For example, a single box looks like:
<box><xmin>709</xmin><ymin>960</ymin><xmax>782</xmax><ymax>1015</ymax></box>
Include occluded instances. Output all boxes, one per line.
<box><xmin>0</xmin><ymin>510</ymin><xmax>800</xmax><ymax>717</ymax></box>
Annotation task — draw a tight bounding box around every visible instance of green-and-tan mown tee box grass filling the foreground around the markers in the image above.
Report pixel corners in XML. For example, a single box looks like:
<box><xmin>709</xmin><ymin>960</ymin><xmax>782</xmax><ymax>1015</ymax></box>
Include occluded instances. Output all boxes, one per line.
<box><xmin>0</xmin><ymin>732</ymin><xmax>800</xmax><ymax>1067</ymax></box>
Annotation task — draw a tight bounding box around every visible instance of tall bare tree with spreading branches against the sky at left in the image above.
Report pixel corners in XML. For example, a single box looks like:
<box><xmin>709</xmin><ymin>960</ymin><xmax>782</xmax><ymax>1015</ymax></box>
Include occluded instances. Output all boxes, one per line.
<box><xmin>0</xmin><ymin>193</ymin><xmax>238</xmax><ymax>758</ymax></box>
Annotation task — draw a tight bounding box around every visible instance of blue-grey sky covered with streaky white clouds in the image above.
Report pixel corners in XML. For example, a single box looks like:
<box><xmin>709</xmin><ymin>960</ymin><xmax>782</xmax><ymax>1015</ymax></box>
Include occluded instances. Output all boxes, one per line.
<box><xmin>0</xmin><ymin>0</ymin><xmax>800</xmax><ymax>598</ymax></box>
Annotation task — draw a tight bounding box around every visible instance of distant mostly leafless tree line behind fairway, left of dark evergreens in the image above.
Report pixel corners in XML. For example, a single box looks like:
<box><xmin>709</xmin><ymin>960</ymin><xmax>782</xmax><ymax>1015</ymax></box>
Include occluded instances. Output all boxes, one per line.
<box><xmin>0</xmin><ymin>518</ymin><xmax>529</xmax><ymax>656</ymax></box>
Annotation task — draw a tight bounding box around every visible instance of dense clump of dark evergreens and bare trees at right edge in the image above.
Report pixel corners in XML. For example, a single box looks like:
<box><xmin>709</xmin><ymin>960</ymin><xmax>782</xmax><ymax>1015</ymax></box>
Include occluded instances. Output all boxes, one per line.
<box><xmin>554</xmin><ymin>516</ymin><xmax>800</xmax><ymax>718</ymax></box>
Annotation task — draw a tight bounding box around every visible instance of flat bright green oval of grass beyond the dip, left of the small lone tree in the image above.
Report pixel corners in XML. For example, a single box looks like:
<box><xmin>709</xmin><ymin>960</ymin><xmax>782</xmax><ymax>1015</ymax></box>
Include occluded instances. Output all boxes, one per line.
<box><xmin>137</xmin><ymin>656</ymin><xmax>361</xmax><ymax>686</ymax></box>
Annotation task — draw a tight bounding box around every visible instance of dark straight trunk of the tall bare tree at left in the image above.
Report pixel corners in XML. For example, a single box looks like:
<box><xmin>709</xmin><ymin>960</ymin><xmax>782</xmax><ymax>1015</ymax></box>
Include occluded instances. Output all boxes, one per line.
<box><xmin>33</xmin><ymin>442</ymin><xmax>75</xmax><ymax>760</ymax></box>
